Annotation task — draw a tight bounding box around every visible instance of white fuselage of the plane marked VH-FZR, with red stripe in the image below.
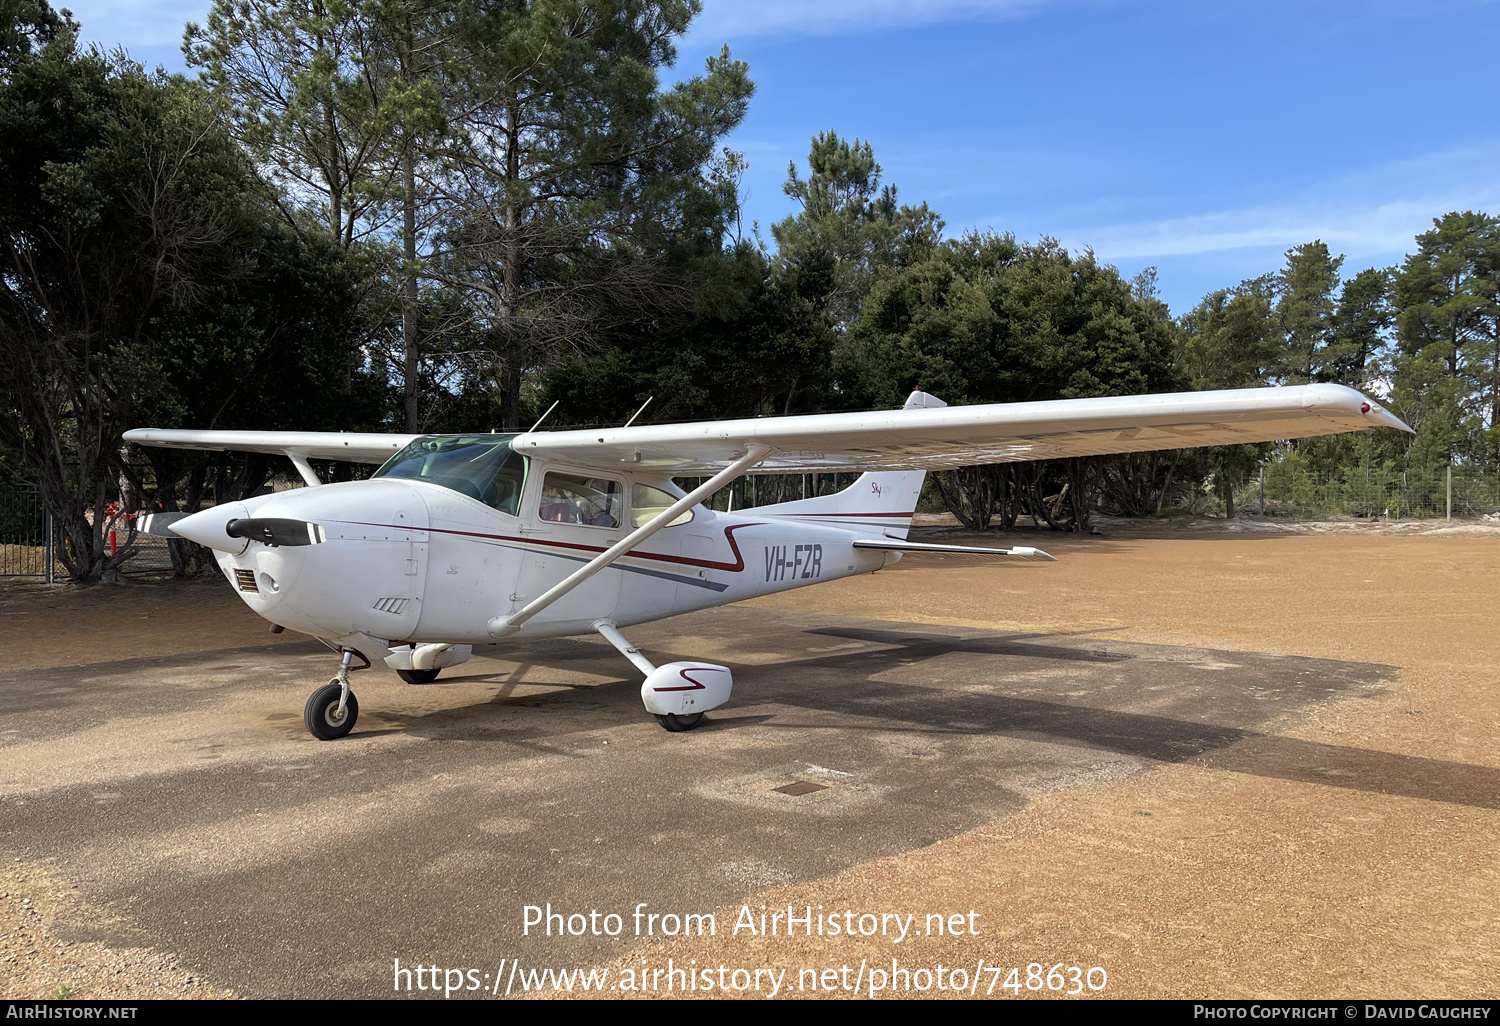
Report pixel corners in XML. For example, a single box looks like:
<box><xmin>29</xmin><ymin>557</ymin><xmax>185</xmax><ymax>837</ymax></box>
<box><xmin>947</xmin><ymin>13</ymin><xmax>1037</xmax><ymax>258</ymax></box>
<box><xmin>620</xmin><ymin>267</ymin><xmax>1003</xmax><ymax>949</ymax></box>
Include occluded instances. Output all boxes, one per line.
<box><xmin>205</xmin><ymin>461</ymin><xmax>896</xmax><ymax>645</ymax></box>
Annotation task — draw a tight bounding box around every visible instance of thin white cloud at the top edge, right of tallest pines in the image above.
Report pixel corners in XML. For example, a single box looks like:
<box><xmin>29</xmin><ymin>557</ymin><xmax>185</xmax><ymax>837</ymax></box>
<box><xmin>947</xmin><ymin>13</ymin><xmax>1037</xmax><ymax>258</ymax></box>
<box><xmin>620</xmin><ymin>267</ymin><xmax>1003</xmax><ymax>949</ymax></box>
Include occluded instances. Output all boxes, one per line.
<box><xmin>689</xmin><ymin>0</ymin><xmax>1049</xmax><ymax>41</ymax></box>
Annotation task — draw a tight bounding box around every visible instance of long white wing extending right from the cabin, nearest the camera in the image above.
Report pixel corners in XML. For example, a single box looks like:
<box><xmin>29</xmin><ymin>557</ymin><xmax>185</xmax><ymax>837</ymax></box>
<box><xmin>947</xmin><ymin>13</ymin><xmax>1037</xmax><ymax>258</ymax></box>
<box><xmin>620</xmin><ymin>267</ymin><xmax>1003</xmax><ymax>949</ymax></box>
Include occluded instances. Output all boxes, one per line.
<box><xmin>513</xmin><ymin>384</ymin><xmax>1410</xmax><ymax>474</ymax></box>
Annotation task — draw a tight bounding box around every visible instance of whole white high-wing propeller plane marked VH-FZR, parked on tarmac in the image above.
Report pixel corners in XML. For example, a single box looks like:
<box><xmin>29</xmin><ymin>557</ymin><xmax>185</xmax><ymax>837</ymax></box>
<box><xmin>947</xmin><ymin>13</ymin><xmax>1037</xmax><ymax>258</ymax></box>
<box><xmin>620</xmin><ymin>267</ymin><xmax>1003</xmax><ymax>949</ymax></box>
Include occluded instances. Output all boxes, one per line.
<box><xmin>125</xmin><ymin>384</ymin><xmax>1410</xmax><ymax>740</ymax></box>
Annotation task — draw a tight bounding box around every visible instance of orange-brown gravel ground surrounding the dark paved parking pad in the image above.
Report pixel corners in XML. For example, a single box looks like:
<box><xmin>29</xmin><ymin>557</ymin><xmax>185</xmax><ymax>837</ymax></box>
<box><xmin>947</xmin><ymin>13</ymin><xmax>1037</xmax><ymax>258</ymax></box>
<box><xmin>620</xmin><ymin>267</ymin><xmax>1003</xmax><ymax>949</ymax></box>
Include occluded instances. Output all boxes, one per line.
<box><xmin>0</xmin><ymin>522</ymin><xmax>1500</xmax><ymax>998</ymax></box>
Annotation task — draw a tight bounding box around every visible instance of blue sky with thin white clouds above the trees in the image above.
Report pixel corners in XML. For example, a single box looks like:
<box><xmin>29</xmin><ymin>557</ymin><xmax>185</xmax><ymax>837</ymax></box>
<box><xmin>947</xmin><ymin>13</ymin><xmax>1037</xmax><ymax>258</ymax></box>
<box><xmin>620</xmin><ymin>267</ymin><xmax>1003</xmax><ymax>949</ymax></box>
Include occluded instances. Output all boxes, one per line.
<box><xmin>59</xmin><ymin>0</ymin><xmax>1500</xmax><ymax>312</ymax></box>
